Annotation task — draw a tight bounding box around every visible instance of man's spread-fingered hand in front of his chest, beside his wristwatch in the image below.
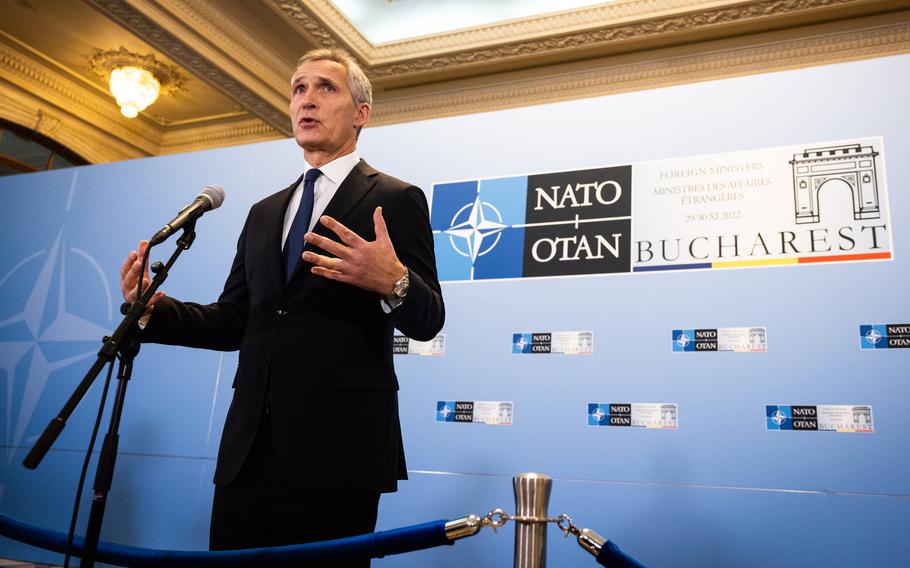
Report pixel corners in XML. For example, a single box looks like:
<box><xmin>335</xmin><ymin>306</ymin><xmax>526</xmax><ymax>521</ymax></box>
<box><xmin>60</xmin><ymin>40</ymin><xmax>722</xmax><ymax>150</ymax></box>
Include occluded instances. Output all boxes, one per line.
<box><xmin>302</xmin><ymin>207</ymin><xmax>407</xmax><ymax>295</ymax></box>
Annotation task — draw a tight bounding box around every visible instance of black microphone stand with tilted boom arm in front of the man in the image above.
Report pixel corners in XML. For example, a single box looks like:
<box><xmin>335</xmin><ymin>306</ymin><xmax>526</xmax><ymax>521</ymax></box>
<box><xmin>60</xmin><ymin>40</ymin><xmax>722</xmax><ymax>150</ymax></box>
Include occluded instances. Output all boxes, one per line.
<box><xmin>22</xmin><ymin>221</ymin><xmax>196</xmax><ymax>568</ymax></box>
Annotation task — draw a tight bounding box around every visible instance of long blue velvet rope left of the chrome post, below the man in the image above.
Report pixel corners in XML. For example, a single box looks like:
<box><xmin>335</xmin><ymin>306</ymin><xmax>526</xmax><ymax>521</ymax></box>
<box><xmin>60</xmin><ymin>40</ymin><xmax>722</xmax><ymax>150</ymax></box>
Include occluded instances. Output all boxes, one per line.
<box><xmin>0</xmin><ymin>513</ymin><xmax>454</xmax><ymax>568</ymax></box>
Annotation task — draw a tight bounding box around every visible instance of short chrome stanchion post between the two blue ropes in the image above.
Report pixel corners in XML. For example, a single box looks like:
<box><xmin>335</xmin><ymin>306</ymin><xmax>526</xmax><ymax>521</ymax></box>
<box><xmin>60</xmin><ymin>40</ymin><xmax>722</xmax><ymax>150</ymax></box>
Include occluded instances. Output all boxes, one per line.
<box><xmin>512</xmin><ymin>473</ymin><xmax>553</xmax><ymax>568</ymax></box>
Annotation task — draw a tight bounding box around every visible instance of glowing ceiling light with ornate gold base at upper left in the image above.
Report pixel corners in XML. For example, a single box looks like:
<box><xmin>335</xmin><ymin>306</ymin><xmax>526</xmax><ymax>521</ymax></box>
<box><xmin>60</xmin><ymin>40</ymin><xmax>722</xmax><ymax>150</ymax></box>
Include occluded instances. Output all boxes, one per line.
<box><xmin>89</xmin><ymin>47</ymin><xmax>183</xmax><ymax>118</ymax></box>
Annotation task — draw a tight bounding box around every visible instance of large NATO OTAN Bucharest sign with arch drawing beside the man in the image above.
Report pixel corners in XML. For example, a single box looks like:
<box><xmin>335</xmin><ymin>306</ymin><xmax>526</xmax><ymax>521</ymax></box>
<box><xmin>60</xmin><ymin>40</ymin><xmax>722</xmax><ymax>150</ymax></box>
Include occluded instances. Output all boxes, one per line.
<box><xmin>431</xmin><ymin>137</ymin><xmax>892</xmax><ymax>281</ymax></box>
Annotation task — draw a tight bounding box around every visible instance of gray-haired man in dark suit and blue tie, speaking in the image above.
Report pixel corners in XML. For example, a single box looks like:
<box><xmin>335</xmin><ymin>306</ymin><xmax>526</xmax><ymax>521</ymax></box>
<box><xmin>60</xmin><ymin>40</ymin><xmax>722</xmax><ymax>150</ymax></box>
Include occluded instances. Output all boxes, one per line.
<box><xmin>121</xmin><ymin>50</ymin><xmax>444</xmax><ymax>565</ymax></box>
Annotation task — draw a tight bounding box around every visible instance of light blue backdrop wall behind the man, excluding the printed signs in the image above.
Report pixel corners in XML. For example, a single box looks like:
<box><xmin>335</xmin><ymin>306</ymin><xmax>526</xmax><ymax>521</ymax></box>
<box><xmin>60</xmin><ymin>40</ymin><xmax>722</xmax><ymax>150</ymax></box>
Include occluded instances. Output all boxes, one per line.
<box><xmin>0</xmin><ymin>56</ymin><xmax>910</xmax><ymax>567</ymax></box>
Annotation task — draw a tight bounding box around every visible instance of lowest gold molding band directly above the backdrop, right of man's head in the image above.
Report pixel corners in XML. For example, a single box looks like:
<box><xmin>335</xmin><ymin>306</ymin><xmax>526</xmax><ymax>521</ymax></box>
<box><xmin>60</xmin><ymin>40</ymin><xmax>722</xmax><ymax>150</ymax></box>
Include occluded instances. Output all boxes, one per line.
<box><xmin>371</xmin><ymin>22</ymin><xmax>910</xmax><ymax>126</ymax></box>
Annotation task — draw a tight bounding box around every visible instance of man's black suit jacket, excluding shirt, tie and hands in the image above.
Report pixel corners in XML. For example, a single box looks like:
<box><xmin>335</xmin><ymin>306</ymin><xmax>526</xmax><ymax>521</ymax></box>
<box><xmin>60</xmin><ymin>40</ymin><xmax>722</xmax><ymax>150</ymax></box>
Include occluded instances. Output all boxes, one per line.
<box><xmin>142</xmin><ymin>160</ymin><xmax>445</xmax><ymax>493</ymax></box>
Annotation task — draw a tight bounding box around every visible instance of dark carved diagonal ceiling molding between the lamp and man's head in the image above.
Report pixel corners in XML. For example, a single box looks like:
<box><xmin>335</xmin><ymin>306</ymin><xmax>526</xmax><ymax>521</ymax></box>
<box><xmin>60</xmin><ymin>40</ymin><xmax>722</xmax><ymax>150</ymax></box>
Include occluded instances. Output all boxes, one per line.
<box><xmin>87</xmin><ymin>0</ymin><xmax>291</xmax><ymax>136</ymax></box>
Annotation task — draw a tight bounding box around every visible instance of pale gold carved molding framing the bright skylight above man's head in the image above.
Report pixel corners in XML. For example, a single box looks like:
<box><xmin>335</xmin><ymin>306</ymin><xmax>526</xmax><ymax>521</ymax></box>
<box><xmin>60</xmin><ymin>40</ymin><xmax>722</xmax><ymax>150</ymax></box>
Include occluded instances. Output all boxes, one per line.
<box><xmin>268</xmin><ymin>0</ymin><xmax>894</xmax><ymax>80</ymax></box>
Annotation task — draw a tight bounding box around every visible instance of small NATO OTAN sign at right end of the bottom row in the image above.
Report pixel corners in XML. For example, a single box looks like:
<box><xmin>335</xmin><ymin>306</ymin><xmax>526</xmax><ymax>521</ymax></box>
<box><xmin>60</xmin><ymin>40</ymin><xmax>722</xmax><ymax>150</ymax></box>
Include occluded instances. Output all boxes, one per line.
<box><xmin>765</xmin><ymin>404</ymin><xmax>874</xmax><ymax>432</ymax></box>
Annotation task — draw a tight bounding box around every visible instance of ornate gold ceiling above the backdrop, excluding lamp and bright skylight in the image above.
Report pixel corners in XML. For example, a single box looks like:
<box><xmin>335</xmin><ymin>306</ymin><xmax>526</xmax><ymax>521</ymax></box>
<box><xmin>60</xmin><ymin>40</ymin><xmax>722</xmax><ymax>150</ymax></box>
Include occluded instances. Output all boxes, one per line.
<box><xmin>0</xmin><ymin>0</ymin><xmax>910</xmax><ymax>162</ymax></box>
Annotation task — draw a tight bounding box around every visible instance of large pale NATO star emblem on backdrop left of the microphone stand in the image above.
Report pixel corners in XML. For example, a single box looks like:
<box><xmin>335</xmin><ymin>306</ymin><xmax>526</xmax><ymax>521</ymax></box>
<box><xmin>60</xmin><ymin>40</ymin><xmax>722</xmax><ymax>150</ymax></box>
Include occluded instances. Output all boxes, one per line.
<box><xmin>0</xmin><ymin>229</ymin><xmax>113</xmax><ymax>465</ymax></box>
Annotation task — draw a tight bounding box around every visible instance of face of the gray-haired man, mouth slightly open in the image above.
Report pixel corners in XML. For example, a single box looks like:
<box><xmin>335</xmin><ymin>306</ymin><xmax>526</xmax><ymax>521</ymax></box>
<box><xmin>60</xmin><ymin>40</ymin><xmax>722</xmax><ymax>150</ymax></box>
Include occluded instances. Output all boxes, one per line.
<box><xmin>291</xmin><ymin>61</ymin><xmax>370</xmax><ymax>159</ymax></box>
